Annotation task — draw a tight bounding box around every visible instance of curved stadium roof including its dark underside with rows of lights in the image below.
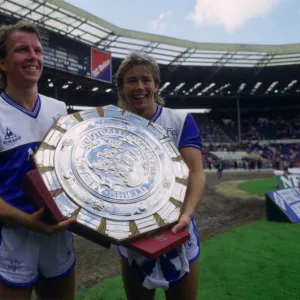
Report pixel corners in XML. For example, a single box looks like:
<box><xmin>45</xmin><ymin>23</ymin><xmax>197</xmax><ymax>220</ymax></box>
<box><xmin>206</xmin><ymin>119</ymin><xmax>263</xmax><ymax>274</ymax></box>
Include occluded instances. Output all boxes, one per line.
<box><xmin>0</xmin><ymin>0</ymin><xmax>300</xmax><ymax>109</ymax></box>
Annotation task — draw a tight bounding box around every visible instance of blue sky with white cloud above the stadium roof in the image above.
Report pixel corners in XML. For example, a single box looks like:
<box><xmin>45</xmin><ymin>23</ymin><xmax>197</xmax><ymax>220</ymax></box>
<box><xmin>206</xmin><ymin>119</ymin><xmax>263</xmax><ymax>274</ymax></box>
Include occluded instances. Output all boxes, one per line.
<box><xmin>65</xmin><ymin>0</ymin><xmax>300</xmax><ymax>45</ymax></box>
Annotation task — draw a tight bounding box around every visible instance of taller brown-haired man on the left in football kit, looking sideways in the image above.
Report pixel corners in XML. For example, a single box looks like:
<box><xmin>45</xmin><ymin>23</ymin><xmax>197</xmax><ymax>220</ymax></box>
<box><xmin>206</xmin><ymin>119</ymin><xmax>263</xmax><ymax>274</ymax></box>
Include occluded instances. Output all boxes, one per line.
<box><xmin>0</xmin><ymin>22</ymin><xmax>75</xmax><ymax>300</ymax></box>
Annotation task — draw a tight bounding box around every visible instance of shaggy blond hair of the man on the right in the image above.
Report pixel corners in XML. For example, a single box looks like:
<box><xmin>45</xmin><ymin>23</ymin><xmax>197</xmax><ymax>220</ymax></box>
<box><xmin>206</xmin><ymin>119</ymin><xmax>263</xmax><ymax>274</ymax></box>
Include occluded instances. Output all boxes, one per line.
<box><xmin>115</xmin><ymin>51</ymin><xmax>165</xmax><ymax>109</ymax></box>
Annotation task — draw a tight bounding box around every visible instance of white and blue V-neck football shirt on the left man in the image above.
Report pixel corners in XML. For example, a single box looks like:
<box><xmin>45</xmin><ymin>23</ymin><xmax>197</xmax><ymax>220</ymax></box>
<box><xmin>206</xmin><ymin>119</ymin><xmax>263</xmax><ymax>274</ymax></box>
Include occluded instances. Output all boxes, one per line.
<box><xmin>0</xmin><ymin>92</ymin><xmax>67</xmax><ymax>213</ymax></box>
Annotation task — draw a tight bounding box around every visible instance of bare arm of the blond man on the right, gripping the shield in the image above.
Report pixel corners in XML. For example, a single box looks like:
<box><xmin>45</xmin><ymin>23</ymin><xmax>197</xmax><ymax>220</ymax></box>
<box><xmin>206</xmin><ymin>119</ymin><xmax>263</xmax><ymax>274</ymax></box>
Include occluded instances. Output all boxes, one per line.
<box><xmin>173</xmin><ymin>147</ymin><xmax>206</xmax><ymax>232</ymax></box>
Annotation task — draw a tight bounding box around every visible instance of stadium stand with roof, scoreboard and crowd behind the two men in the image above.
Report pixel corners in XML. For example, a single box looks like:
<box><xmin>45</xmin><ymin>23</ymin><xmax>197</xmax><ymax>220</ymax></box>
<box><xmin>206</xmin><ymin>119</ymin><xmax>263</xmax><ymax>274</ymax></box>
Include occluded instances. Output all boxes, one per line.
<box><xmin>0</xmin><ymin>0</ymin><xmax>300</xmax><ymax>169</ymax></box>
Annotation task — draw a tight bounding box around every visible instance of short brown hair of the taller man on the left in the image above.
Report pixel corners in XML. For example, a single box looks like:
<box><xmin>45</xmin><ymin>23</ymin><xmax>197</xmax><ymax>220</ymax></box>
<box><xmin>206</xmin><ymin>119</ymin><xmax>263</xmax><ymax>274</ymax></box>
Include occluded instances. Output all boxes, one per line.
<box><xmin>0</xmin><ymin>21</ymin><xmax>41</xmax><ymax>89</ymax></box>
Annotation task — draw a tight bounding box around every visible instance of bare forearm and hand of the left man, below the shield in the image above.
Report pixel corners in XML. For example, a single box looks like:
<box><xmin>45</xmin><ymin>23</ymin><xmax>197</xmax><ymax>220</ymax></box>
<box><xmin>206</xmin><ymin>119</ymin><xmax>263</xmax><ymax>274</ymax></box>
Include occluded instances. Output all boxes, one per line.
<box><xmin>0</xmin><ymin>198</ymin><xmax>76</xmax><ymax>234</ymax></box>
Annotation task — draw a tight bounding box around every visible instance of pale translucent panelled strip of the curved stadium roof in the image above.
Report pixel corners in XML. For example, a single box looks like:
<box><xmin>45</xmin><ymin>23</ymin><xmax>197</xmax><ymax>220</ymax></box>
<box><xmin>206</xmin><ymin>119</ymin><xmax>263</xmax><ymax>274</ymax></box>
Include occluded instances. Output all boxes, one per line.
<box><xmin>0</xmin><ymin>0</ymin><xmax>300</xmax><ymax>68</ymax></box>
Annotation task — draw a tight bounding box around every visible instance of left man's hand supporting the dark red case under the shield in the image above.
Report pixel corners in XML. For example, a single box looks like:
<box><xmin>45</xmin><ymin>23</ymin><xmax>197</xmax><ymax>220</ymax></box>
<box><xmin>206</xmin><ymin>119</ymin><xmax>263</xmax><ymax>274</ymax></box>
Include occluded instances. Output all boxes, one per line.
<box><xmin>23</xmin><ymin>208</ymin><xmax>76</xmax><ymax>235</ymax></box>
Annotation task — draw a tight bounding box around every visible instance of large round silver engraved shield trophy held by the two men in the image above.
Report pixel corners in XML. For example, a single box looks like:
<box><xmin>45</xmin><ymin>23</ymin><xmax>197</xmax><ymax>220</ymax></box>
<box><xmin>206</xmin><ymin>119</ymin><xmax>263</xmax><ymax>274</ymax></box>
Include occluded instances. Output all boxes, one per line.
<box><xmin>34</xmin><ymin>105</ymin><xmax>188</xmax><ymax>244</ymax></box>
